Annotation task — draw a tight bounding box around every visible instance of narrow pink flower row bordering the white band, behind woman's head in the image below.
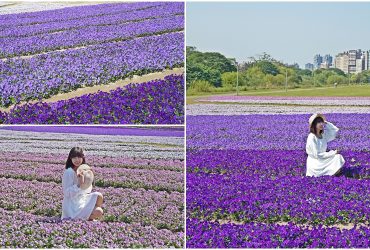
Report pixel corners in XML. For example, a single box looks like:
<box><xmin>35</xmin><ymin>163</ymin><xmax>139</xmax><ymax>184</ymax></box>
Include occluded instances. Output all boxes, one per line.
<box><xmin>0</xmin><ymin>152</ymin><xmax>184</xmax><ymax>172</ymax></box>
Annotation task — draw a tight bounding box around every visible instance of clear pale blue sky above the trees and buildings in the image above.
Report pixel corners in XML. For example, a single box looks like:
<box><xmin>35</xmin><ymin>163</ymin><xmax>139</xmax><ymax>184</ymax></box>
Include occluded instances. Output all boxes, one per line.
<box><xmin>186</xmin><ymin>2</ymin><xmax>370</xmax><ymax>68</ymax></box>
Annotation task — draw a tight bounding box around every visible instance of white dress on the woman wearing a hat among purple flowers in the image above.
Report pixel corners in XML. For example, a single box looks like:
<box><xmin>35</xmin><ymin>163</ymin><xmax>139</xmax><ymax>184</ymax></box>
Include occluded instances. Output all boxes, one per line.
<box><xmin>306</xmin><ymin>122</ymin><xmax>345</xmax><ymax>177</ymax></box>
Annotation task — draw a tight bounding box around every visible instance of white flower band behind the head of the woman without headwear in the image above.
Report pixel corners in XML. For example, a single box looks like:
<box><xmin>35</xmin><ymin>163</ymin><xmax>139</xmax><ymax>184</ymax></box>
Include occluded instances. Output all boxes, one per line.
<box><xmin>0</xmin><ymin>129</ymin><xmax>184</xmax><ymax>159</ymax></box>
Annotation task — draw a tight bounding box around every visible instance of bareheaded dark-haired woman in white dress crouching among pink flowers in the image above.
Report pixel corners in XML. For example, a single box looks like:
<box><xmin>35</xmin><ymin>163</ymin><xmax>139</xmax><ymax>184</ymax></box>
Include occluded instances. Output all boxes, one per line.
<box><xmin>62</xmin><ymin>147</ymin><xmax>103</xmax><ymax>220</ymax></box>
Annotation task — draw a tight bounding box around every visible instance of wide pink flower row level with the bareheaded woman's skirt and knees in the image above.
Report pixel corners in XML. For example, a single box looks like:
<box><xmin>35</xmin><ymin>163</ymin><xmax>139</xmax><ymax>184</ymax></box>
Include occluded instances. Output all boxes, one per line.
<box><xmin>0</xmin><ymin>178</ymin><xmax>184</xmax><ymax>232</ymax></box>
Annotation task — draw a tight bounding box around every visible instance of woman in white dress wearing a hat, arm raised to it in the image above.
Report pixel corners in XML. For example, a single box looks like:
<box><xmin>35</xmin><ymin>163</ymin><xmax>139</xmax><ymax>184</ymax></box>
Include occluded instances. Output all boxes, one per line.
<box><xmin>306</xmin><ymin>114</ymin><xmax>345</xmax><ymax>177</ymax></box>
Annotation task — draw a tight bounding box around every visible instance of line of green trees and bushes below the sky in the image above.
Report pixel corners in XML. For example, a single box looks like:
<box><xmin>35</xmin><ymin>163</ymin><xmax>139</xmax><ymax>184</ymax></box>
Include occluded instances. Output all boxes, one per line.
<box><xmin>186</xmin><ymin>46</ymin><xmax>370</xmax><ymax>94</ymax></box>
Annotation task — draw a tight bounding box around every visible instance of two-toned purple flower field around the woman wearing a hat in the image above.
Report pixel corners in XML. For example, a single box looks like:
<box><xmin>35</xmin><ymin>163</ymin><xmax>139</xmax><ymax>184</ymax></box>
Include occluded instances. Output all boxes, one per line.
<box><xmin>186</xmin><ymin>113</ymin><xmax>370</xmax><ymax>248</ymax></box>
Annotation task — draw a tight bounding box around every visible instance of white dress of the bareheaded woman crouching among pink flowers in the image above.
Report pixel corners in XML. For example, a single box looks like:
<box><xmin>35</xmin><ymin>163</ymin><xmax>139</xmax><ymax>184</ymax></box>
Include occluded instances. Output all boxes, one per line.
<box><xmin>62</xmin><ymin>168</ymin><xmax>100</xmax><ymax>220</ymax></box>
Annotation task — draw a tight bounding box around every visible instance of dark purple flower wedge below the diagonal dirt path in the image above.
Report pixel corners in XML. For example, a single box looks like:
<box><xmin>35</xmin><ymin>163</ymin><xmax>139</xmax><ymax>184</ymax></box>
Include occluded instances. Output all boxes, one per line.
<box><xmin>0</xmin><ymin>75</ymin><xmax>184</xmax><ymax>124</ymax></box>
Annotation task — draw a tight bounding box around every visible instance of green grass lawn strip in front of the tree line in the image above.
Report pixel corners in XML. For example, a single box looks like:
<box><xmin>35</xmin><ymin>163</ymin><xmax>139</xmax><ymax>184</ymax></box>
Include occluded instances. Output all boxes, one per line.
<box><xmin>186</xmin><ymin>84</ymin><xmax>370</xmax><ymax>104</ymax></box>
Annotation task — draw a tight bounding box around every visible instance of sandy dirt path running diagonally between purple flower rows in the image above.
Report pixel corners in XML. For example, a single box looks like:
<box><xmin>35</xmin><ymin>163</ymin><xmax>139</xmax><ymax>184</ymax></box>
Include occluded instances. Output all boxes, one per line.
<box><xmin>0</xmin><ymin>68</ymin><xmax>184</xmax><ymax>112</ymax></box>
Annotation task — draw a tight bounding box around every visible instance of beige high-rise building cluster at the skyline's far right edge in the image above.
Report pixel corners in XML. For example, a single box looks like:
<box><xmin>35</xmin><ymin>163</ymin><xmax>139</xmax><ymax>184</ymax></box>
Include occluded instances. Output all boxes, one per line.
<box><xmin>334</xmin><ymin>49</ymin><xmax>369</xmax><ymax>74</ymax></box>
